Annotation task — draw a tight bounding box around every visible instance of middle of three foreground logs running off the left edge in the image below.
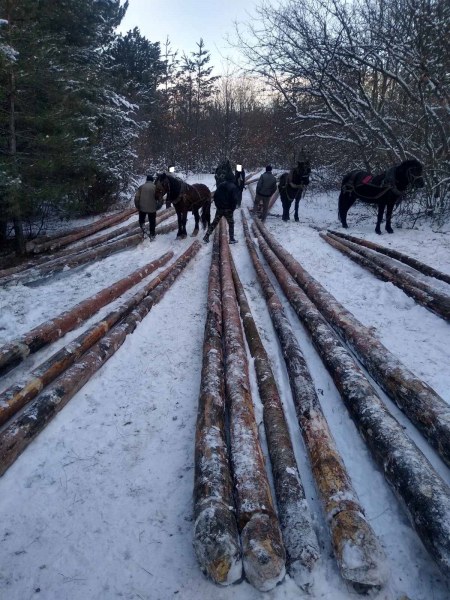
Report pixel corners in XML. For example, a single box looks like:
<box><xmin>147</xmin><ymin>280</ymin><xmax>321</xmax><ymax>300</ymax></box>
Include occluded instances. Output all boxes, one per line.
<box><xmin>0</xmin><ymin>253</ymin><xmax>181</xmax><ymax>425</ymax></box>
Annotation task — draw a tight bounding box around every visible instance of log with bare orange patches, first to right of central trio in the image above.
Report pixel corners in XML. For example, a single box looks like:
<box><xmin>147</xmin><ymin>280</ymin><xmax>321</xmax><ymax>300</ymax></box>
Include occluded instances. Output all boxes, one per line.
<box><xmin>244</xmin><ymin>217</ymin><xmax>387</xmax><ymax>591</ymax></box>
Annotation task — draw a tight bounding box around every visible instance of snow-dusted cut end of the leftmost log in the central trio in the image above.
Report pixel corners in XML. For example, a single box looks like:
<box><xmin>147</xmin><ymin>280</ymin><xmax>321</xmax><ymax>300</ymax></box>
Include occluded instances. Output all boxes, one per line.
<box><xmin>193</xmin><ymin>503</ymin><xmax>242</xmax><ymax>585</ymax></box>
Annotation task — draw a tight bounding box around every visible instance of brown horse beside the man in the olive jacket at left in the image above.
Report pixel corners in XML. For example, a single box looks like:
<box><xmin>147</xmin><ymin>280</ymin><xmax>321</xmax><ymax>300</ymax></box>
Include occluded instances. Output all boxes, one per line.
<box><xmin>155</xmin><ymin>173</ymin><xmax>211</xmax><ymax>239</ymax></box>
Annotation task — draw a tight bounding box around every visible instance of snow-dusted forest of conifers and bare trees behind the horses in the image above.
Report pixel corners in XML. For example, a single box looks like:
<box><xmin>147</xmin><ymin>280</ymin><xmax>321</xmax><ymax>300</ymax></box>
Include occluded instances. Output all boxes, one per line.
<box><xmin>0</xmin><ymin>0</ymin><xmax>450</xmax><ymax>252</ymax></box>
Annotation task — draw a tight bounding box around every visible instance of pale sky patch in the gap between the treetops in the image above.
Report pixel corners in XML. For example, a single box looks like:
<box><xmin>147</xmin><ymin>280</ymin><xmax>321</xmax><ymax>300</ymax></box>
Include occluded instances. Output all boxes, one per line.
<box><xmin>119</xmin><ymin>0</ymin><xmax>259</xmax><ymax>72</ymax></box>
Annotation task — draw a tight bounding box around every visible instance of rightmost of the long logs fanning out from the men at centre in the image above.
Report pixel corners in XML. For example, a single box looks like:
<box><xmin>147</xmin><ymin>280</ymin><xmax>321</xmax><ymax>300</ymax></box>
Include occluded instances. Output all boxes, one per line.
<box><xmin>253</xmin><ymin>227</ymin><xmax>450</xmax><ymax>466</ymax></box>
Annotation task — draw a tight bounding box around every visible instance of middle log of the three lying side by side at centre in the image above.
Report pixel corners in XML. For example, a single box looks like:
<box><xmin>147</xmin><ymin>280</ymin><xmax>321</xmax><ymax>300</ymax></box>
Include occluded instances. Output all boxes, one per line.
<box><xmin>219</xmin><ymin>219</ymin><xmax>286</xmax><ymax>591</ymax></box>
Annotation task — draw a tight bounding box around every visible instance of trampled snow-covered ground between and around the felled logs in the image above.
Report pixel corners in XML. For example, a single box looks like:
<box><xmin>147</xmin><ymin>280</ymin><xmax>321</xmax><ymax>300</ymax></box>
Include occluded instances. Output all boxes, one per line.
<box><xmin>0</xmin><ymin>175</ymin><xmax>450</xmax><ymax>600</ymax></box>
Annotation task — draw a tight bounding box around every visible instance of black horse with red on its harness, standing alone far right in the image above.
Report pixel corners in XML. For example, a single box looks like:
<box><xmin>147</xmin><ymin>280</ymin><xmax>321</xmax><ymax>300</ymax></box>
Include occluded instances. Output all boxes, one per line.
<box><xmin>338</xmin><ymin>159</ymin><xmax>425</xmax><ymax>234</ymax></box>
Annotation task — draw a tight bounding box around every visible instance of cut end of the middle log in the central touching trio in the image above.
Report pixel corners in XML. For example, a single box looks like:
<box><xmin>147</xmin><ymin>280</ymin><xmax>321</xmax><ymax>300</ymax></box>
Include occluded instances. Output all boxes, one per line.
<box><xmin>241</xmin><ymin>514</ymin><xmax>286</xmax><ymax>592</ymax></box>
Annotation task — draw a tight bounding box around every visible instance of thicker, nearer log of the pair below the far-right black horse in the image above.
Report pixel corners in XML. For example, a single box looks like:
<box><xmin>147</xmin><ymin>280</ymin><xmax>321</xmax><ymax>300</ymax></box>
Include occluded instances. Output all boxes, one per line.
<box><xmin>319</xmin><ymin>233</ymin><xmax>450</xmax><ymax>321</ymax></box>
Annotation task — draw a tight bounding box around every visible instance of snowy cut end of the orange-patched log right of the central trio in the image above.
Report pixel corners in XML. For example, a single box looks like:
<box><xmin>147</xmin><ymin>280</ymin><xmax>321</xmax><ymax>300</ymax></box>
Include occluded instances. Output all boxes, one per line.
<box><xmin>331</xmin><ymin>510</ymin><xmax>388</xmax><ymax>593</ymax></box>
